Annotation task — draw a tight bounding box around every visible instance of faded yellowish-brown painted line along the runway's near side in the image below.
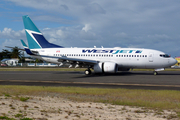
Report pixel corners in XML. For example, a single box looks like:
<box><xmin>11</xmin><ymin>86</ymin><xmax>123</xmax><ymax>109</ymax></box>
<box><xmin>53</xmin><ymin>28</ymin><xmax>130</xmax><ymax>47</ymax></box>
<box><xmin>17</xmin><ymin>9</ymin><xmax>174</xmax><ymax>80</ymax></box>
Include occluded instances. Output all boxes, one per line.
<box><xmin>0</xmin><ymin>80</ymin><xmax>180</xmax><ymax>87</ymax></box>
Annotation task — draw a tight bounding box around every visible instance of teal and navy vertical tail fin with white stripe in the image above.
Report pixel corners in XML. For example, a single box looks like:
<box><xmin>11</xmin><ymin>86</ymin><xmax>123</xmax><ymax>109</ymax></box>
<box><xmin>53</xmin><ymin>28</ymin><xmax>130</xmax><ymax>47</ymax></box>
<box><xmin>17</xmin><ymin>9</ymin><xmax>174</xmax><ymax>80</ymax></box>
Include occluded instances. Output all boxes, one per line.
<box><xmin>22</xmin><ymin>15</ymin><xmax>63</xmax><ymax>49</ymax></box>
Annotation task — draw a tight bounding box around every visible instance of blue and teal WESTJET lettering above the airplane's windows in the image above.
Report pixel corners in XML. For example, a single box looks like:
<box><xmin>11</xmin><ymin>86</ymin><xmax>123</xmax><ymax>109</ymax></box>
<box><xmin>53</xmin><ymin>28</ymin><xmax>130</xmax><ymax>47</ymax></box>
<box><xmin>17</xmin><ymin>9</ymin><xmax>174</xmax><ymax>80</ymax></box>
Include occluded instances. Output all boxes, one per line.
<box><xmin>82</xmin><ymin>49</ymin><xmax>142</xmax><ymax>54</ymax></box>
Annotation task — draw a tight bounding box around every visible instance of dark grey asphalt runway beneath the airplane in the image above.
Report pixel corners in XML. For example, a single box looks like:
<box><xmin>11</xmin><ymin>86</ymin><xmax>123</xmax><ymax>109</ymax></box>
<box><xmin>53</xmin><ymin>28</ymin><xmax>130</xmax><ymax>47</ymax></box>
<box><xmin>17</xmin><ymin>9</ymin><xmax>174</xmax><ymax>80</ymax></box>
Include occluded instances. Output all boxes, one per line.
<box><xmin>0</xmin><ymin>71</ymin><xmax>180</xmax><ymax>90</ymax></box>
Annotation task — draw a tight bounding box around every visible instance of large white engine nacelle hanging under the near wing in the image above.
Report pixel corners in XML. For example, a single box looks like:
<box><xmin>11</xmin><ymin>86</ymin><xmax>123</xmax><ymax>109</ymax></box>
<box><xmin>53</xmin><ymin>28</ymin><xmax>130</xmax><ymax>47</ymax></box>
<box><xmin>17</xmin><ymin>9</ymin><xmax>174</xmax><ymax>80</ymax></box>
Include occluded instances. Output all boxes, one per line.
<box><xmin>94</xmin><ymin>62</ymin><xmax>118</xmax><ymax>73</ymax></box>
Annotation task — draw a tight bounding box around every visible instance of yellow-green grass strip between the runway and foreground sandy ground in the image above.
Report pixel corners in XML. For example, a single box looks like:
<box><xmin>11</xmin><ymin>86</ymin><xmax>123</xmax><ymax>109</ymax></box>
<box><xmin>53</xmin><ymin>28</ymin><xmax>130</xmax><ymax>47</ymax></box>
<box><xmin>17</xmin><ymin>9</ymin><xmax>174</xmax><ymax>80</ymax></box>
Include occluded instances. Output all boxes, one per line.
<box><xmin>0</xmin><ymin>85</ymin><xmax>180</xmax><ymax>113</ymax></box>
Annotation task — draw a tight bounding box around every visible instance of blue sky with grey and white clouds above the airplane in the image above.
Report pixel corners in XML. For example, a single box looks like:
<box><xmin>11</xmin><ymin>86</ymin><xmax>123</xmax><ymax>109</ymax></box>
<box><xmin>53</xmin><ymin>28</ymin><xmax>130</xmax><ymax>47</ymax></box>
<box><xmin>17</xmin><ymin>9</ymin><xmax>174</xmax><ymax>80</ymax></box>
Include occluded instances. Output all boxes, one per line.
<box><xmin>0</xmin><ymin>0</ymin><xmax>180</xmax><ymax>57</ymax></box>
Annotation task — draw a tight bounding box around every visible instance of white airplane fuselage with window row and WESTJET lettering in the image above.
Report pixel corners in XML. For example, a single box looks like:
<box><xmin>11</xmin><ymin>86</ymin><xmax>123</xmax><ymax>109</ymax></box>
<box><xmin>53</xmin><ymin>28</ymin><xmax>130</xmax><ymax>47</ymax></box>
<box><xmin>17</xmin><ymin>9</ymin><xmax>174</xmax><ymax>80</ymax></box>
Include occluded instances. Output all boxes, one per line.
<box><xmin>30</xmin><ymin>48</ymin><xmax>177</xmax><ymax>69</ymax></box>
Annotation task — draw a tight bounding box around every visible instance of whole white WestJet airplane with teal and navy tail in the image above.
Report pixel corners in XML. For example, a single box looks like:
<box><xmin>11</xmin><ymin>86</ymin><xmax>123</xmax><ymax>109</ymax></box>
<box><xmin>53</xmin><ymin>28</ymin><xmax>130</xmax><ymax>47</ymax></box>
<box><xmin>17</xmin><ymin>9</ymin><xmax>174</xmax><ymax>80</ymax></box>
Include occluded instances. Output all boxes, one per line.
<box><xmin>21</xmin><ymin>15</ymin><xmax>177</xmax><ymax>75</ymax></box>
